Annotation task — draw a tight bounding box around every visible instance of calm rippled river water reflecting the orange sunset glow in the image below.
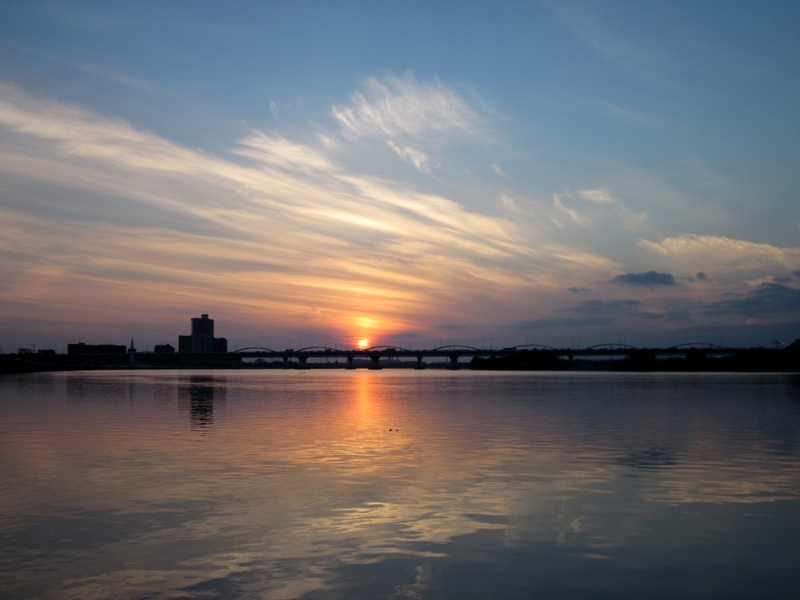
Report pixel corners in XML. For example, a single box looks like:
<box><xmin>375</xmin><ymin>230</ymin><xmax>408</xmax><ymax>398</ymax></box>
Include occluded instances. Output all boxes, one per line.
<box><xmin>0</xmin><ymin>370</ymin><xmax>800</xmax><ymax>599</ymax></box>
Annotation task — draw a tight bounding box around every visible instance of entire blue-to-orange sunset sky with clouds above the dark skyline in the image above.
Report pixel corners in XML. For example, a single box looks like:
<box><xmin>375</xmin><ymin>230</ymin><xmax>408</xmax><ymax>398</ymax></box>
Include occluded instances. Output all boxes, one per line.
<box><xmin>0</xmin><ymin>0</ymin><xmax>800</xmax><ymax>352</ymax></box>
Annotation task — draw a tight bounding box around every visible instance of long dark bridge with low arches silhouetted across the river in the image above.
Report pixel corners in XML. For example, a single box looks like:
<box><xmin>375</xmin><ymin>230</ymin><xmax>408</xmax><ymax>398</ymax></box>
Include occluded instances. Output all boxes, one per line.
<box><xmin>227</xmin><ymin>342</ymin><xmax>753</xmax><ymax>370</ymax></box>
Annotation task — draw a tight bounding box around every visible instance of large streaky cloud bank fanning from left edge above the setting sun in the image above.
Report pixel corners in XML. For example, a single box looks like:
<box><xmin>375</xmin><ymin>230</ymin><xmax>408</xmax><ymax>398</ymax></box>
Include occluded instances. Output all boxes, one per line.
<box><xmin>0</xmin><ymin>79</ymin><xmax>617</xmax><ymax>344</ymax></box>
